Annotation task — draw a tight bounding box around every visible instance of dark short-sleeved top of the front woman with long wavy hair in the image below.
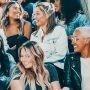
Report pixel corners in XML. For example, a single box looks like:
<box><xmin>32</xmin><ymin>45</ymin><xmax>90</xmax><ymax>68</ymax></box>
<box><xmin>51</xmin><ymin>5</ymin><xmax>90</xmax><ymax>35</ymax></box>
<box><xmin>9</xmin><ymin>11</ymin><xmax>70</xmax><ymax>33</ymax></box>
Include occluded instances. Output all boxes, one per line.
<box><xmin>11</xmin><ymin>64</ymin><xmax>58</xmax><ymax>90</ymax></box>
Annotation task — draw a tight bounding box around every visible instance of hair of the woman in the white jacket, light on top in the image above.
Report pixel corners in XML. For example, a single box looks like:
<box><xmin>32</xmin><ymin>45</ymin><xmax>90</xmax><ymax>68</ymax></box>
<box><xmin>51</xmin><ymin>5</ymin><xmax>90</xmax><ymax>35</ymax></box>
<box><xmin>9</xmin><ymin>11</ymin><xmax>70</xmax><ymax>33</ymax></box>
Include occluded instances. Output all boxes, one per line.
<box><xmin>36</xmin><ymin>2</ymin><xmax>56</xmax><ymax>34</ymax></box>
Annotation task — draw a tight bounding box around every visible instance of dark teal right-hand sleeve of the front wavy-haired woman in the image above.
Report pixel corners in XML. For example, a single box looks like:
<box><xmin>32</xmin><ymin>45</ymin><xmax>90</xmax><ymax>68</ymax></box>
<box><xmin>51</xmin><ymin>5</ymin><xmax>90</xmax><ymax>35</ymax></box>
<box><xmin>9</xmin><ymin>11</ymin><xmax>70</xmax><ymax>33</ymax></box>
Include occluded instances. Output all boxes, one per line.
<box><xmin>45</xmin><ymin>63</ymin><xmax>59</xmax><ymax>82</ymax></box>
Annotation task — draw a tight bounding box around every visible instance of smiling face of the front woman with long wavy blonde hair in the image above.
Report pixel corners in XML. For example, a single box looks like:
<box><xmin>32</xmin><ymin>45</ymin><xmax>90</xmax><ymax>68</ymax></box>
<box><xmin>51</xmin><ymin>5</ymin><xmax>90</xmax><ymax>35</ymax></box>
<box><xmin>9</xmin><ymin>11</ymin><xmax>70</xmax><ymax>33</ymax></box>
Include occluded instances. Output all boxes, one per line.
<box><xmin>20</xmin><ymin>48</ymin><xmax>35</xmax><ymax>68</ymax></box>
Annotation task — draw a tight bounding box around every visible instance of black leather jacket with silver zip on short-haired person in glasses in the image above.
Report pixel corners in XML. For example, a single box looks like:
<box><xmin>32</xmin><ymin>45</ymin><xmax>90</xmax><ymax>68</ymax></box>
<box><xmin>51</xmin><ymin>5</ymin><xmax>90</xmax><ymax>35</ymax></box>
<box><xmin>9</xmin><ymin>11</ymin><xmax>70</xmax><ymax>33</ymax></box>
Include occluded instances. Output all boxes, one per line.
<box><xmin>64</xmin><ymin>53</ymin><xmax>82</xmax><ymax>90</ymax></box>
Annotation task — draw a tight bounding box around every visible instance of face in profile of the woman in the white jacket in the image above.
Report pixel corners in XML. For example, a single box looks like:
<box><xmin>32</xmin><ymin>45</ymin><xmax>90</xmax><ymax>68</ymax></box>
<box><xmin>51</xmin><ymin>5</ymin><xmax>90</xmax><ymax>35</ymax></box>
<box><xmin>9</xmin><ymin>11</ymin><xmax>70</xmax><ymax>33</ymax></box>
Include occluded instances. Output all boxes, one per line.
<box><xmin>35</xmin><ymin>7</ymin><xmax>48</xmax><ymax>27</ymax></box>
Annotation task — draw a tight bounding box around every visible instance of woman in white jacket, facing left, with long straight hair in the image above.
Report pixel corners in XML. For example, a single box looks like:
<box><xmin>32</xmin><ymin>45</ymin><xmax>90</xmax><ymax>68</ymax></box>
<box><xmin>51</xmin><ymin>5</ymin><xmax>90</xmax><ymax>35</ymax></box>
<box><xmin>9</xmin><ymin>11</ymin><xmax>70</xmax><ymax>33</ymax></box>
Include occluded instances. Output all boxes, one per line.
<box><xmin>31</xmin><ymin>2</ymin><xmax>68</xmax><ymax>87</ymax></box>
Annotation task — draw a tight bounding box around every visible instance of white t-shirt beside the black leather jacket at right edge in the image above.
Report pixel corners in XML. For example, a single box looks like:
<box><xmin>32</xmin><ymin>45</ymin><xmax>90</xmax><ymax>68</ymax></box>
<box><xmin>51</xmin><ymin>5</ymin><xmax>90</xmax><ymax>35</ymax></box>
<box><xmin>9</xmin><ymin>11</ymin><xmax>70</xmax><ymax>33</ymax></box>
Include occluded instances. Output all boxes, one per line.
<box><xmin>81</xmin><ymin>58</ymin><xmax>90</xmax><ymax>90</ymax></box>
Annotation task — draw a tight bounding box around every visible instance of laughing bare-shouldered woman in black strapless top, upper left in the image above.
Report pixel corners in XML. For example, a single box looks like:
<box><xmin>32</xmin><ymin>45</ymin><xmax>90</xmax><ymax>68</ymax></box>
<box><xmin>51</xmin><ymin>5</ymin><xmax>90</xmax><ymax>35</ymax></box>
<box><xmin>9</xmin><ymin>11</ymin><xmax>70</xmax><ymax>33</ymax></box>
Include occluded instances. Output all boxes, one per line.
<box><xmin>2</xmin><ymin>1</ymin><xmax>31</xmax><ymax>62</ymax></box>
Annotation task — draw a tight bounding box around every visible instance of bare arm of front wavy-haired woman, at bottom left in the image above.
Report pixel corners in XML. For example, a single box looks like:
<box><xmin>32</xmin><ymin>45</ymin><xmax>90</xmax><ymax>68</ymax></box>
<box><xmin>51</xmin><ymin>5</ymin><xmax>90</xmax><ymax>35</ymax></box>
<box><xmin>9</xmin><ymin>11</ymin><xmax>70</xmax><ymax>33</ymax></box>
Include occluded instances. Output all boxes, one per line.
<box><xmin>10</xmin><ymin>80</ymin><xmax>23</xmax><ymax>90</ymax></box>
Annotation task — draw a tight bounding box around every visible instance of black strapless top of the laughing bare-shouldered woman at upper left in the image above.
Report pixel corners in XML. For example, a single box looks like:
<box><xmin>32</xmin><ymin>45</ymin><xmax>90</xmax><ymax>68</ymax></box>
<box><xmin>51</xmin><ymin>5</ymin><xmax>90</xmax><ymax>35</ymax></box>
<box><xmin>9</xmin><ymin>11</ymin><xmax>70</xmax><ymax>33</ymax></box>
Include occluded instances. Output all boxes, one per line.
<box><xmin>7</xmin><ymin>34</ymin><xmax>28</xmax><ymax>62</ymax></box>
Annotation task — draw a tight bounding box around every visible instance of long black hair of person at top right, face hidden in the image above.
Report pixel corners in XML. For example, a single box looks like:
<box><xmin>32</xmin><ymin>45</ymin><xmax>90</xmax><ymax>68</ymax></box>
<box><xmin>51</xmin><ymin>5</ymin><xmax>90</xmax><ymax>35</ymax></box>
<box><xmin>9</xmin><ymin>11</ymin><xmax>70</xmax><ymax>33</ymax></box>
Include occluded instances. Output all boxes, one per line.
<box><xmin>61</xmin><ymin>0</ymin><xmax>82</xmax><ymax>24</ymax></box>
